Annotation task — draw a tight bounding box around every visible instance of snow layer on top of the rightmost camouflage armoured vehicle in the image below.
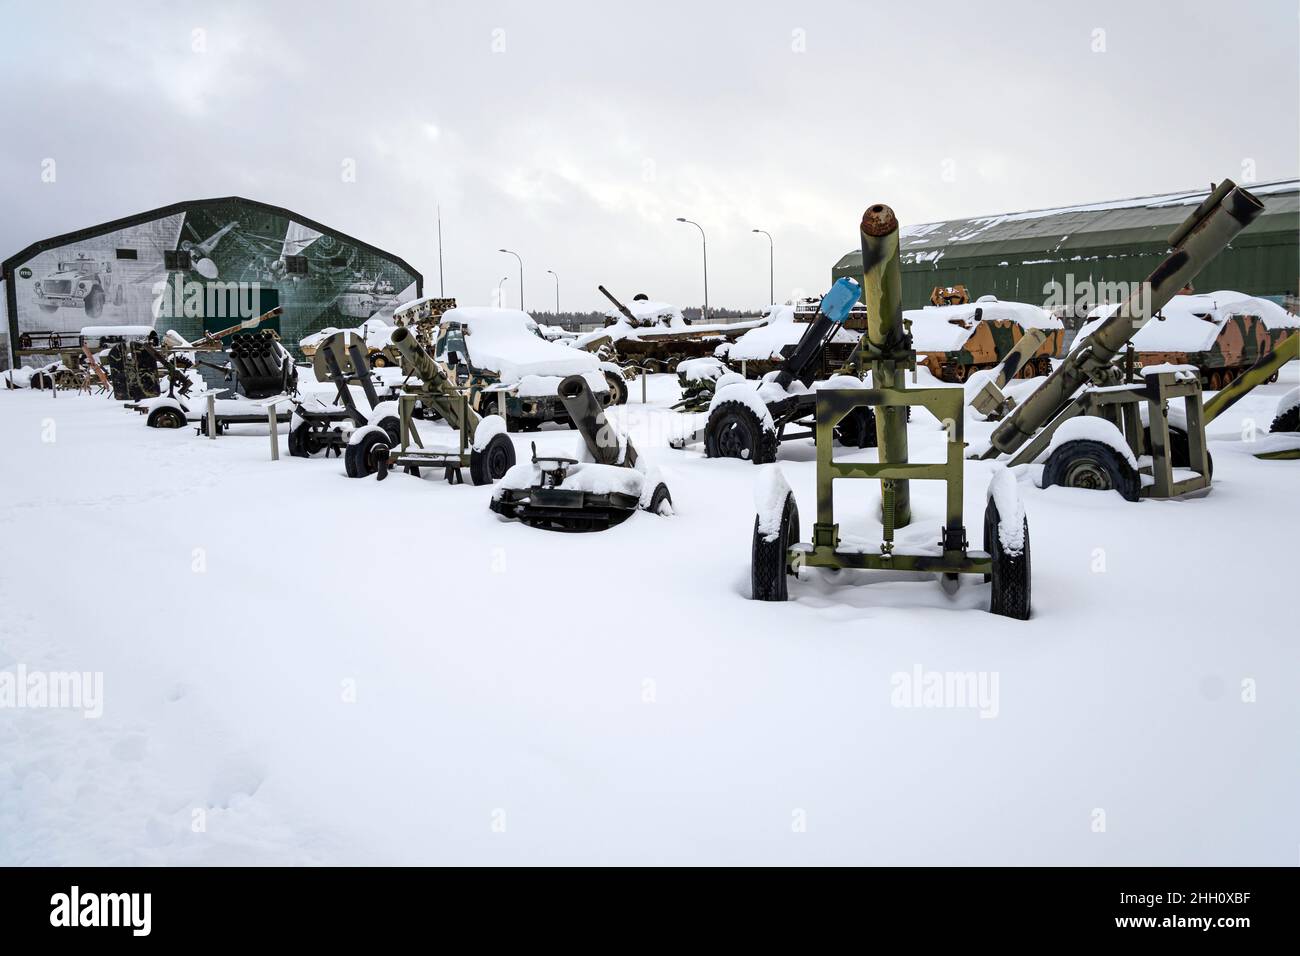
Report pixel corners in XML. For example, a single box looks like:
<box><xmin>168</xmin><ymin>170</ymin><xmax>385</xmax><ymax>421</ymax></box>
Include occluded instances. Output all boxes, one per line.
<box><xmin>1074</xmin><ymin>290</ymin><xmax>1300</xmax><ymax>352</ymax></box>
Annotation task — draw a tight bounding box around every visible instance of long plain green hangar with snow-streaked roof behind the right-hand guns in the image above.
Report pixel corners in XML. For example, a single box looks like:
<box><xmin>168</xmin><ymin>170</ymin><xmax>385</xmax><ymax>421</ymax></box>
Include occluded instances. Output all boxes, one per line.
<box><xmin>831</xmin><ymin>179</ymin><xmax>1300</xmax><ymax>317</ymax></box>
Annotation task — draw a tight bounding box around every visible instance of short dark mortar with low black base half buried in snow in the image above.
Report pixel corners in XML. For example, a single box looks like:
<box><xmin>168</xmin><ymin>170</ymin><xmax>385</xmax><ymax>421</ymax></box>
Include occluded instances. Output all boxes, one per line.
<box><xmin>491</xmin><ymin>375</ymin><xmax>672</xmax><ymax>531</ymax></box>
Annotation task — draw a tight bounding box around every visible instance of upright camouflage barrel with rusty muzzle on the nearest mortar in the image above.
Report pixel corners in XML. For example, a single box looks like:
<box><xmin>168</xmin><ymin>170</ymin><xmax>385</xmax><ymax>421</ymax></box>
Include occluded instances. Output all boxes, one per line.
<box><xmin>859</xmin><ymin>203</ymin><xmax>915</xmax><ymax>528</ymax></box>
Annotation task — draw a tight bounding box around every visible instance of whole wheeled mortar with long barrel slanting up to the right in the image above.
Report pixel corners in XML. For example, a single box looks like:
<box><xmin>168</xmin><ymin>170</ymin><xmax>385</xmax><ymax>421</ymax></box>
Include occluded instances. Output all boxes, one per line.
<box><xmin>978</xmin><ymin>179</ymin><xmax>1264</xmax><ymax>501</ymax></box>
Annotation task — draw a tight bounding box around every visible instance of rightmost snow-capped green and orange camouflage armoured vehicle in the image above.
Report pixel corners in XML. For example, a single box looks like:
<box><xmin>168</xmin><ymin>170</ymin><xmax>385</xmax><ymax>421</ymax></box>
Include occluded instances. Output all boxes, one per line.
<box><xmin>1079</xmin><ymin>291</ymin><xmax>1300</xmax><ymax>392</ymax></box>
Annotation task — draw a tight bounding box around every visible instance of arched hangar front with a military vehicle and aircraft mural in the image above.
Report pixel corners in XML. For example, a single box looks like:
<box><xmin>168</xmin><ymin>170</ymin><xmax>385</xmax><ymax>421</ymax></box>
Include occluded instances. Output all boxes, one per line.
<box><xmin>0</xmin><ymin>196</ymin><xmax>424</xmax><ymax>364</ymax></box>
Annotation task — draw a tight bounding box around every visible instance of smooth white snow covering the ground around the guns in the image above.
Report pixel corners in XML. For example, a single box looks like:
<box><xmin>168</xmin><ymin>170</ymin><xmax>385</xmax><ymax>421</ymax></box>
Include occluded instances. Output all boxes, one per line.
<box><xmin>0</xmin><ymin>363</ymin><xmax>1300</xmax><ymax>865</ymax></box>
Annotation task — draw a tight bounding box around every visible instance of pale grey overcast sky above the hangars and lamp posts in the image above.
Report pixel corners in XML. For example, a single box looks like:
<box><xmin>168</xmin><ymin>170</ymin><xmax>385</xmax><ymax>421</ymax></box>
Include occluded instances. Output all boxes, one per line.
<box><xmin>0</xmin><ymin>0</ymin><xmax>1300</xmax><ymax>311</ymax></box>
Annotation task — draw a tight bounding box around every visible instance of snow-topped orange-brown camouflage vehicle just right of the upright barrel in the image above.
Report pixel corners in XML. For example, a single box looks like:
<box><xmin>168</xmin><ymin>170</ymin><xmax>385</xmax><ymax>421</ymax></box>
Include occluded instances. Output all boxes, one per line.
<box><xmin>904</xmin><ymin>295</ymin><xmax>1065</xmax><ymax>382</ymax></box>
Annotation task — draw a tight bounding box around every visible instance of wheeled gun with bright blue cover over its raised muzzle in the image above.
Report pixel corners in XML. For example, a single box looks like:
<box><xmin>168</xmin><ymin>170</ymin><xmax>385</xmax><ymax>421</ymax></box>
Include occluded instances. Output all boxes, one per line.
<box><xmin>668</xmin><ymin>278</ymin><xmax>876</xmax><ymax>464</ymax></box>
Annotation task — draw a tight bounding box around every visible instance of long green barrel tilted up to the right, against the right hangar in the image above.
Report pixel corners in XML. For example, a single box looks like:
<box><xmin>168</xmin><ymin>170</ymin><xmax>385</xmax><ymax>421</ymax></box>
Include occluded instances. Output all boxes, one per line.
<box><xmin>982</xmin><ymin>179</ymin><xmax>1264</xmax><ymax>457</ymax></box>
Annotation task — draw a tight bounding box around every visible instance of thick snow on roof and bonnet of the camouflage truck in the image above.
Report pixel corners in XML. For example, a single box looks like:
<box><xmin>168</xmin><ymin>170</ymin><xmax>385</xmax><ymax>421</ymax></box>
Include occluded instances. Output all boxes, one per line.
<box><xmin>439</xmin><ymin>306</ymin><xmax>601</xmax><ymax>385</ymax></box>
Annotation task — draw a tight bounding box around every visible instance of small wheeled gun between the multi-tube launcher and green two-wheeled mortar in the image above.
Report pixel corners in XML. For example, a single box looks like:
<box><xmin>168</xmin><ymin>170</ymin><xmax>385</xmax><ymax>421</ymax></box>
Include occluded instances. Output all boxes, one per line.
<box><xmin>289</xmin><ymin>330</ymin><xmax>400</xmax><ymax>458</ymax></box>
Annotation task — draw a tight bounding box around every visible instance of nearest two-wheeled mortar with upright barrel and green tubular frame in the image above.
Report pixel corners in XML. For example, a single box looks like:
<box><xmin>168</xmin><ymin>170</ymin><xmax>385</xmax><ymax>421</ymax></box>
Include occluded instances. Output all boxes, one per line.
<box><xmin>750</xmin><ymin>204</ymin><xmax>1030</xmax><ymax>620</ymax></box>
